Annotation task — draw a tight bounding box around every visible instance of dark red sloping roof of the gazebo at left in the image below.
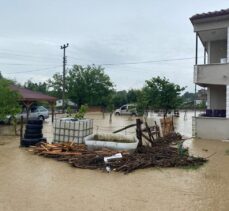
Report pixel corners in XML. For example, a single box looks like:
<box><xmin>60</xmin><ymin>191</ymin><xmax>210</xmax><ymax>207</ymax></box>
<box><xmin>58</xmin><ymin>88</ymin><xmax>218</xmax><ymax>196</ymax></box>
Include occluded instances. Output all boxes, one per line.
<box><xmin>10</xmin><ymin>85</ymin><xmax>56</xmax><ymax>102</ymax></box>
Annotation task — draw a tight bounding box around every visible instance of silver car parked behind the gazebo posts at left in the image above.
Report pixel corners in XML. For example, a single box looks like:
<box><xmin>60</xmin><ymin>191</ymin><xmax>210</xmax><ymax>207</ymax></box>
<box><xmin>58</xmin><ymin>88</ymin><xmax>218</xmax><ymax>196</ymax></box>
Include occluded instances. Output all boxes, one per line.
<box><xmin>5</xmin><ymin>106</ymin><xmax>49</xmax><ymax>124</ymax></box>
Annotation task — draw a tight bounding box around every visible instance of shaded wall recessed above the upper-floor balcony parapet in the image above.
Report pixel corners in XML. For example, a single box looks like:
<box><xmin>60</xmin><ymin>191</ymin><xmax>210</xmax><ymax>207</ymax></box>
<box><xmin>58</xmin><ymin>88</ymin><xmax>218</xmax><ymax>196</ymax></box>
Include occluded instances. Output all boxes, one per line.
<box><xmin>209</xmin><ymin>40</ymin><xmax>227</xmax><ymax>63</ymax></box>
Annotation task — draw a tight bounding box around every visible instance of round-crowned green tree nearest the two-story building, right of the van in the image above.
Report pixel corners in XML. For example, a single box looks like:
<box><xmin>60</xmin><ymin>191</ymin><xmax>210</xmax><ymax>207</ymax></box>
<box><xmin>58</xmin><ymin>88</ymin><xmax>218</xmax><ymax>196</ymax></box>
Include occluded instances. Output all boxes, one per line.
<box><xmin>143</xmin><ymin>77</ymin><xmax>185</xmax><ymax>115</ymax></box>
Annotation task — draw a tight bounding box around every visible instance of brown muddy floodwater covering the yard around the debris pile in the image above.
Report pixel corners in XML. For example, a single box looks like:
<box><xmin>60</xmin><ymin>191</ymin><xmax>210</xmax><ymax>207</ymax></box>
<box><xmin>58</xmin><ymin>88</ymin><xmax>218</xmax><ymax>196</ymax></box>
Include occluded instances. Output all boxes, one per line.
<box><xmin>0</xmin><ymin>112</ymin><xmax>229</xmax><ymax>211</ymax></box>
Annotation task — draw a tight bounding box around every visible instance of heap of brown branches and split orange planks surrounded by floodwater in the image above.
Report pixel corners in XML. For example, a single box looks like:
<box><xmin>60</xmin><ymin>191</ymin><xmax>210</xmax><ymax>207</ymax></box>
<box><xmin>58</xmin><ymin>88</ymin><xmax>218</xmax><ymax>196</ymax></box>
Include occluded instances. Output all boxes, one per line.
<box><xmin>30</xmin><ymin>134</ymin><xmax>207</xmax><ymax>173</ymax></box>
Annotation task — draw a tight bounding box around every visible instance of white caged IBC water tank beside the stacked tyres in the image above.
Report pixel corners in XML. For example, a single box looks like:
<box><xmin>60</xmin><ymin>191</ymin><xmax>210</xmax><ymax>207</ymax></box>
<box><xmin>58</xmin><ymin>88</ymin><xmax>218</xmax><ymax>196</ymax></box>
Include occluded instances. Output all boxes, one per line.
<box><xmin>53</xmin><ymin>118</ymin><xmax>93</xmax><ymax>143</ymax></box>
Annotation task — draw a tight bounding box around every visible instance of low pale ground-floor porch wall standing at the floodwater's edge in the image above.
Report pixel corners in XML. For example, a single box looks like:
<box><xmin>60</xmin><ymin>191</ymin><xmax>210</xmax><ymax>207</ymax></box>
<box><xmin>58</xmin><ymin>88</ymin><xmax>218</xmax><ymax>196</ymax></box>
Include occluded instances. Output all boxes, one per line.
<box><xmin>193</xmin><ymin>117</ymin><xmax>229</xmax><ymax>140</ymax></box>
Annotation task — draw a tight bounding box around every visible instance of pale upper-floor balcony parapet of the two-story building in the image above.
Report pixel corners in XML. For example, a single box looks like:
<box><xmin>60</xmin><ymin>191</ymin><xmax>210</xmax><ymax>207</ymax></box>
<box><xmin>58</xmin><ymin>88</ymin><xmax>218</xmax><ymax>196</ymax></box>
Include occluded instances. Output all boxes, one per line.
<box><xmin>194</xmin><ymin>63</ymin><xmax>229</xmax><ymax>86</ymax></box>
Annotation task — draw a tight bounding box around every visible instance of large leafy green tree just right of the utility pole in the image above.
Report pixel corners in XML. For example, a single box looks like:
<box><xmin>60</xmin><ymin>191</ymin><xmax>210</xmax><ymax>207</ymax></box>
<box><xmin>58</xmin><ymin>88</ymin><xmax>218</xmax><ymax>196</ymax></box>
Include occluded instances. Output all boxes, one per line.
<box><xmin>66</xmin><ymin>65</ymin><xmax>113</xmax><ymax>107</ymax></box>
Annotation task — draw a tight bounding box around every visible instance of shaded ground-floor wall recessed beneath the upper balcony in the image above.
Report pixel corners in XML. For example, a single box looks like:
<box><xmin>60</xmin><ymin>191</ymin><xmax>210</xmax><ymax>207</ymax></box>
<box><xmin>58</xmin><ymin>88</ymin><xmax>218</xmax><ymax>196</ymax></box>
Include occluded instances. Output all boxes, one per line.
<box><xmin>208</xmin><ymin>85</ymin><xmax>226</xmax><ymax>109</ymax></box>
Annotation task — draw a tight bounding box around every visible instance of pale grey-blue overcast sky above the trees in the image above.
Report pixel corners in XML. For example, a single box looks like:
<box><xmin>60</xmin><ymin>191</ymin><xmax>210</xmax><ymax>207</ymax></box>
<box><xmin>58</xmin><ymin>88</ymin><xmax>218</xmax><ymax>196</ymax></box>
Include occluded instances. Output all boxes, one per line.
<box><xmin>0</xmin><ymin>0</ymin><xmax>229</xmax><ymax>91</ymax></box>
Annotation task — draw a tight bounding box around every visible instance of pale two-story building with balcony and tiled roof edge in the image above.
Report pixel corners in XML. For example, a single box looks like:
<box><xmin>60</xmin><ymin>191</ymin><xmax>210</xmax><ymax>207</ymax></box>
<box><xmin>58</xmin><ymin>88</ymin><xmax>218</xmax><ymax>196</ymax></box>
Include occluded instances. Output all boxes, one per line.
<box><xmin>190</xmin><ymin>9</ymin><xmax>229</xmax><ymax>139</ymax></box>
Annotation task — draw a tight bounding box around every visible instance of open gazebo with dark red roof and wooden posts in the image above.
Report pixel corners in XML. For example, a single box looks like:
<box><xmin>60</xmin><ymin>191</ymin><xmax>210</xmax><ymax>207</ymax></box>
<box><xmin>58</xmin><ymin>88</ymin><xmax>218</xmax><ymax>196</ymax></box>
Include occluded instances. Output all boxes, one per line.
<box><xmin>10</xmin><ymin>85</ymin><xmax>56</xmax><ymax>122</ymax></box>
